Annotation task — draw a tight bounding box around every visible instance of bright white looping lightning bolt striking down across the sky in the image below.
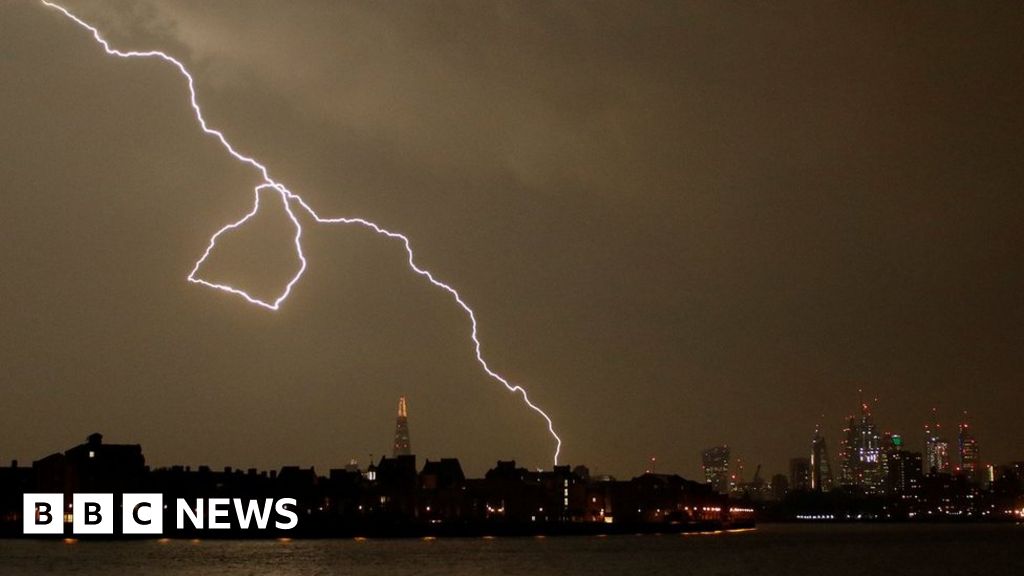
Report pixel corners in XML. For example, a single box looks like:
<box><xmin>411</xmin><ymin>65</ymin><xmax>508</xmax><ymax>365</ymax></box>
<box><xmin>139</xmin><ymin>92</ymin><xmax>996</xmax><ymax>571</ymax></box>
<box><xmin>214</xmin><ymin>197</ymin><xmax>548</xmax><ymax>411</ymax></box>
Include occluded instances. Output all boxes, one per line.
<box><xmin>40</xmin><ymin>0</ymin><xmax>562</xmax><ymax>464</ymax></box>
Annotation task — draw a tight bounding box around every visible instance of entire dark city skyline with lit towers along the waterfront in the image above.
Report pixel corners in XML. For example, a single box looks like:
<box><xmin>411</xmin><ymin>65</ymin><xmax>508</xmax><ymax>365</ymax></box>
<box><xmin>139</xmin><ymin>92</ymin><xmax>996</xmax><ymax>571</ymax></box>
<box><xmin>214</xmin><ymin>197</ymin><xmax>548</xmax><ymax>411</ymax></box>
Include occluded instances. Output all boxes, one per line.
<box><xmin>6</xmin><ymin>414</ymin><xmax>1024</xmax><ymax>535</ymax></box>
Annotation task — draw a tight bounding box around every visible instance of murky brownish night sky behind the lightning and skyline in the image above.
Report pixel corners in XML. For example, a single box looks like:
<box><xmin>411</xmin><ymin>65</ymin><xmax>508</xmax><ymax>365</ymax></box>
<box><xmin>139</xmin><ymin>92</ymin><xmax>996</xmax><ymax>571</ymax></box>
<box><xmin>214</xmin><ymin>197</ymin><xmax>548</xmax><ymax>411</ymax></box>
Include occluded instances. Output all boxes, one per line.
<box><xmin>0</xmin><ymin>1</ymin><xmax>1024</xmax><ymax>479</ymax></box>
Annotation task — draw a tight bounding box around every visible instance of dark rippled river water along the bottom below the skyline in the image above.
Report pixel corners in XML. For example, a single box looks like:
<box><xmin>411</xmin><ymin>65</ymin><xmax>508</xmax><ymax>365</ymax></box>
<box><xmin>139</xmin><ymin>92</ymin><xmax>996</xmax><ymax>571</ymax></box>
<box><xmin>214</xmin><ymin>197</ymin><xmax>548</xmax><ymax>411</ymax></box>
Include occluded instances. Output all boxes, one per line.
<box><xmin>0</xmin><ymin>525</ymin><xmax>1024</xmax><ymax>576</ymax></box>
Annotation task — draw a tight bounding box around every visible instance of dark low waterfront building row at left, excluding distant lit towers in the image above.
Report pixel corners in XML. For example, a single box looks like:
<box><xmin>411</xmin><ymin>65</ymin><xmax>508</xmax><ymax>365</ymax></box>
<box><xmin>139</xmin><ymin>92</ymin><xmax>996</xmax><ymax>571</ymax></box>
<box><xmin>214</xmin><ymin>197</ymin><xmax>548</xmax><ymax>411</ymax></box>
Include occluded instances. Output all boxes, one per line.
<box><xmin>0</xmin><ymin>435</ymin><xmax>754</xmax><ymax>538</ymax></box>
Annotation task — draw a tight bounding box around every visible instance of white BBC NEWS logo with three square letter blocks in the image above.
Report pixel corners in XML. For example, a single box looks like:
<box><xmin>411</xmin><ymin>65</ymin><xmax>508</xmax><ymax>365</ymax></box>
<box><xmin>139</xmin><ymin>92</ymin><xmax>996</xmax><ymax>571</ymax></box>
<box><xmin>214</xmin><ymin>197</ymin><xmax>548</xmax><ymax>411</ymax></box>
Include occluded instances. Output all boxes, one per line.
<box><xmin>22</xmin><ymin>493</ymin><xmax>299</xmax><ymax>535</ymax></box>
